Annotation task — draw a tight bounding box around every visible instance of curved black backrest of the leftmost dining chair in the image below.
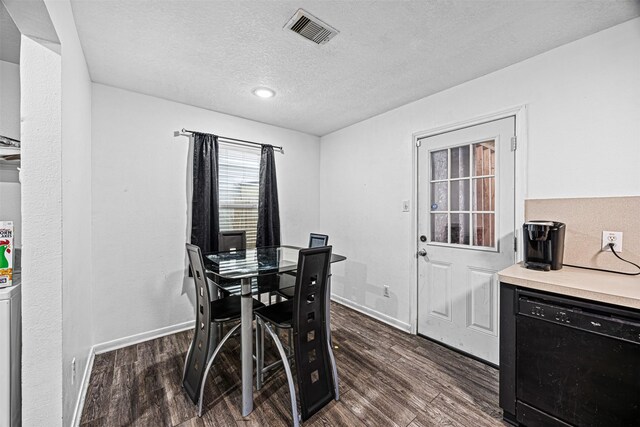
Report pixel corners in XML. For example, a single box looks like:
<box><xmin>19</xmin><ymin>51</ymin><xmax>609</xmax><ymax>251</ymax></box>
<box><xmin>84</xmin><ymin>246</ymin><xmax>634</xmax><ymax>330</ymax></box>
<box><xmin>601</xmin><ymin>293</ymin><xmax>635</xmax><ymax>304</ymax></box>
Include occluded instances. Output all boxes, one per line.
<box><xmin>183</xmin><ymin>243</ymin><xmax>211</xmax><ymax>403</ymax></box>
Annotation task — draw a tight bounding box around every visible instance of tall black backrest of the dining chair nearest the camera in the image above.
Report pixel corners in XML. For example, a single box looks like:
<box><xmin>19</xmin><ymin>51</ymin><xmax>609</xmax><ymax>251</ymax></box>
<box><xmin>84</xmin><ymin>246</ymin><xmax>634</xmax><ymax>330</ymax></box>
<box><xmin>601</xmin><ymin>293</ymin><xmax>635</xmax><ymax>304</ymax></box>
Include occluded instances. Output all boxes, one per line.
<box><xmin>293</xmin><ymin>246</ymin><xmax>335</xmax><ymax>421</ymax></box>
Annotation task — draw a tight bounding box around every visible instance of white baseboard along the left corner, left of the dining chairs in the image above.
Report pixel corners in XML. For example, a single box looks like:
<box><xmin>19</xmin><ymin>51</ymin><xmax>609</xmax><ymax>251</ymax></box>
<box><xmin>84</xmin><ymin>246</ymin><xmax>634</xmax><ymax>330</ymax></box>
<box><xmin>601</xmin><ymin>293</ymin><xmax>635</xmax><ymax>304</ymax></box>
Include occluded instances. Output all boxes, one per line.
<box><xmin>71</xmin><ymin>320</ymin><xmax>194</xmax><ymax>427</ymax></box>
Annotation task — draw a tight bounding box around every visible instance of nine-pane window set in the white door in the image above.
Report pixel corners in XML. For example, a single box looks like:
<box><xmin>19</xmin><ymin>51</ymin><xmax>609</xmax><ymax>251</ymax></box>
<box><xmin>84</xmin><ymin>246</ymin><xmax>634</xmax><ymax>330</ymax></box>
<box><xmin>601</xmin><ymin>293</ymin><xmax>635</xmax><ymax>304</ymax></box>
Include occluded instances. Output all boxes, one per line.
<box><xmin>430</xmin><ymin>140</ymin><xmax>496</xmax><ymax>248</ymax></box>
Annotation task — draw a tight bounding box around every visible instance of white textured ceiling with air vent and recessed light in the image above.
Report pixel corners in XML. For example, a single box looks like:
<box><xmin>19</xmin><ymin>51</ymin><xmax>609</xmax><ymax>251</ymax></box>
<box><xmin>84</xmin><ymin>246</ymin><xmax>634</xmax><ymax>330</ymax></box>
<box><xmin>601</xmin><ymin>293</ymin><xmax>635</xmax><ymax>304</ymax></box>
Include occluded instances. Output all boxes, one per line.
<box><xmin>72</xmin><ymin>0</ymin><xmax>640</xmax><ymax>135</ymax></box>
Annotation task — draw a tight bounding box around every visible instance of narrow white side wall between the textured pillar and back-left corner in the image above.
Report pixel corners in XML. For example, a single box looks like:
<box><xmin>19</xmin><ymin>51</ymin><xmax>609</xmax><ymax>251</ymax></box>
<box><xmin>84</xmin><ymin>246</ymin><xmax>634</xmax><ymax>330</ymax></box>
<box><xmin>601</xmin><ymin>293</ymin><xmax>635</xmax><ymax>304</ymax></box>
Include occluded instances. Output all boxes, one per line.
<box><xmin>46</xmin><ymin>0</ymin><xmax>93</xmax><ymax>425</ymax></box>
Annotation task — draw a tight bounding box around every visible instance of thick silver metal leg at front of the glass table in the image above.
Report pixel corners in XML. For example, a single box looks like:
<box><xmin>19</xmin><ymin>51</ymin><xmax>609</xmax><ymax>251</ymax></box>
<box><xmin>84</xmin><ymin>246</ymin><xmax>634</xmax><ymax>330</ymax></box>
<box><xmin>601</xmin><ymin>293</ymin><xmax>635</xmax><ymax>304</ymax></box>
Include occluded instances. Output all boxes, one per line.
<box><xmin>240</xmin><ymin>278</ymin><xmax>253</xmax><ymax>417</ymax></box>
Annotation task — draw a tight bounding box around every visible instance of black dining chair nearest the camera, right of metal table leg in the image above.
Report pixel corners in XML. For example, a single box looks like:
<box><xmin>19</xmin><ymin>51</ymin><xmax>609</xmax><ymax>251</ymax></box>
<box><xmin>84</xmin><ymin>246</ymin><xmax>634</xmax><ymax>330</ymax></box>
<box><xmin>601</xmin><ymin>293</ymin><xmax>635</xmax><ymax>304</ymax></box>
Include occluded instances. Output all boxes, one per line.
<box><xmin>255</xmin><ymin>246</ymin><xmax>339</xmax><ymax>426</ymax></box>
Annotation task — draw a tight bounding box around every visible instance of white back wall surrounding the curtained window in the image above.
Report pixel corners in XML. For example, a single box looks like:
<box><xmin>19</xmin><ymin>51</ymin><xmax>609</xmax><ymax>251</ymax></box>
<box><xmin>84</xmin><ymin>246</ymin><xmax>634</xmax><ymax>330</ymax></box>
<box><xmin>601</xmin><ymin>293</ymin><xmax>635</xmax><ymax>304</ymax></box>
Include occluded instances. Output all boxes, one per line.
<box><xmin>92</xmin><ymin>84</ymin><xmax>319</xmax><ymax>343</ymax></box>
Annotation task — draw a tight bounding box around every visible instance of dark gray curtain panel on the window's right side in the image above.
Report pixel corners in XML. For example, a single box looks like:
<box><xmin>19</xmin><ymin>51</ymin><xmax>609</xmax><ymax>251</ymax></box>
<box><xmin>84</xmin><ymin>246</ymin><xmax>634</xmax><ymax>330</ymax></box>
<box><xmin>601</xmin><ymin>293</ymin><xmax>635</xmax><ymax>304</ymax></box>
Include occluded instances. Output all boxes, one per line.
<box><xmin>256</xmin><ymin>145</ymin><xmax>280</xmax><ymax>248</ymax></box>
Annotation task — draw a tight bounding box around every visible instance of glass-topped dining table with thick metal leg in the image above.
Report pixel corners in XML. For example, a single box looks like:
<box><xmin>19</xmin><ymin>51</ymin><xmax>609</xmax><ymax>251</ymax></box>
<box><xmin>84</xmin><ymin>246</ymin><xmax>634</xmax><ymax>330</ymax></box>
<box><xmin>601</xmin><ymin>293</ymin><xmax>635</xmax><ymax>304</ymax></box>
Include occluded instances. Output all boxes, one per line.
<box><xmin>203</xmin><ymin>246</ymin><xmax>347</xmax><ymax>416</ymax></box>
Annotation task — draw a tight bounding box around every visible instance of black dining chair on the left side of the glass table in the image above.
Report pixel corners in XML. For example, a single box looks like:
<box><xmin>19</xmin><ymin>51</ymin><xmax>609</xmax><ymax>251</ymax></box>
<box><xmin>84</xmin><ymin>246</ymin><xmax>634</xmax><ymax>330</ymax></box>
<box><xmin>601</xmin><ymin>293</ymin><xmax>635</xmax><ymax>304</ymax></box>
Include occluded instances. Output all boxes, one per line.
<box><xmin>182</xmin><ymin>243</ymin><xmax>264</xmax><ymax>417</ymax></box>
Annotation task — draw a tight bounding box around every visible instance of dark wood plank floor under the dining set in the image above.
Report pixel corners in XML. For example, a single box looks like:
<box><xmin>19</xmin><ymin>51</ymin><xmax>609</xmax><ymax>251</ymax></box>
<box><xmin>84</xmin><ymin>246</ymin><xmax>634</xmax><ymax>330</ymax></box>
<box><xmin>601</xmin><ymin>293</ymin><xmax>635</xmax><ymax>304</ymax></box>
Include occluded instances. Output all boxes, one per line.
<box><xmin>81</xmin><ymin>304</ymin><xmax>503</xmax><ymax>427</ymax></box>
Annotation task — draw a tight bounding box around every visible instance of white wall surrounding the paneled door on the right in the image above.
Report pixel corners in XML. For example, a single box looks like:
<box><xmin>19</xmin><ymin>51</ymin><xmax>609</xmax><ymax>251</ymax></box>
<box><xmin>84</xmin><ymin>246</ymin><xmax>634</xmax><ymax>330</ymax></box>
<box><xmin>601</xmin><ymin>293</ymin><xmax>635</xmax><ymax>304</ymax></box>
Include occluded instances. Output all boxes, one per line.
<box><xmin>320</xmin><ymin>18</ymin><xmax>640</xmax><ymax>329</ymax></box>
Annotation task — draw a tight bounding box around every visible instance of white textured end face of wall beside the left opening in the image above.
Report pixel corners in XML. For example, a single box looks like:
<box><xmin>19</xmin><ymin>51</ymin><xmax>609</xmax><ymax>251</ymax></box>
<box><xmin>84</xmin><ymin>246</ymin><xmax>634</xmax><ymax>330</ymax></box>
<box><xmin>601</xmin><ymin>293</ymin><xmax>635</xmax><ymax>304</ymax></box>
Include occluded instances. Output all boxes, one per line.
<box><xmin>20</xmin><ymin>36</ymin><xmax>63</xmax><ymax>426</ymax></box>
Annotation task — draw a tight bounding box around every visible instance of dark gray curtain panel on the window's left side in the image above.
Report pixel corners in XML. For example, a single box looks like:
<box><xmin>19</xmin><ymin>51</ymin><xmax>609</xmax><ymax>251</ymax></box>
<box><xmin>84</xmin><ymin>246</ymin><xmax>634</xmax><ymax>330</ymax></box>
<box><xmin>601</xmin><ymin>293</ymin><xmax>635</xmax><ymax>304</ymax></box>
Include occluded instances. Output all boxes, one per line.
<box><xmin>191</xmin><ymin>132</ymin><xmax>220</xmax><ymax>252</ymax></box>
